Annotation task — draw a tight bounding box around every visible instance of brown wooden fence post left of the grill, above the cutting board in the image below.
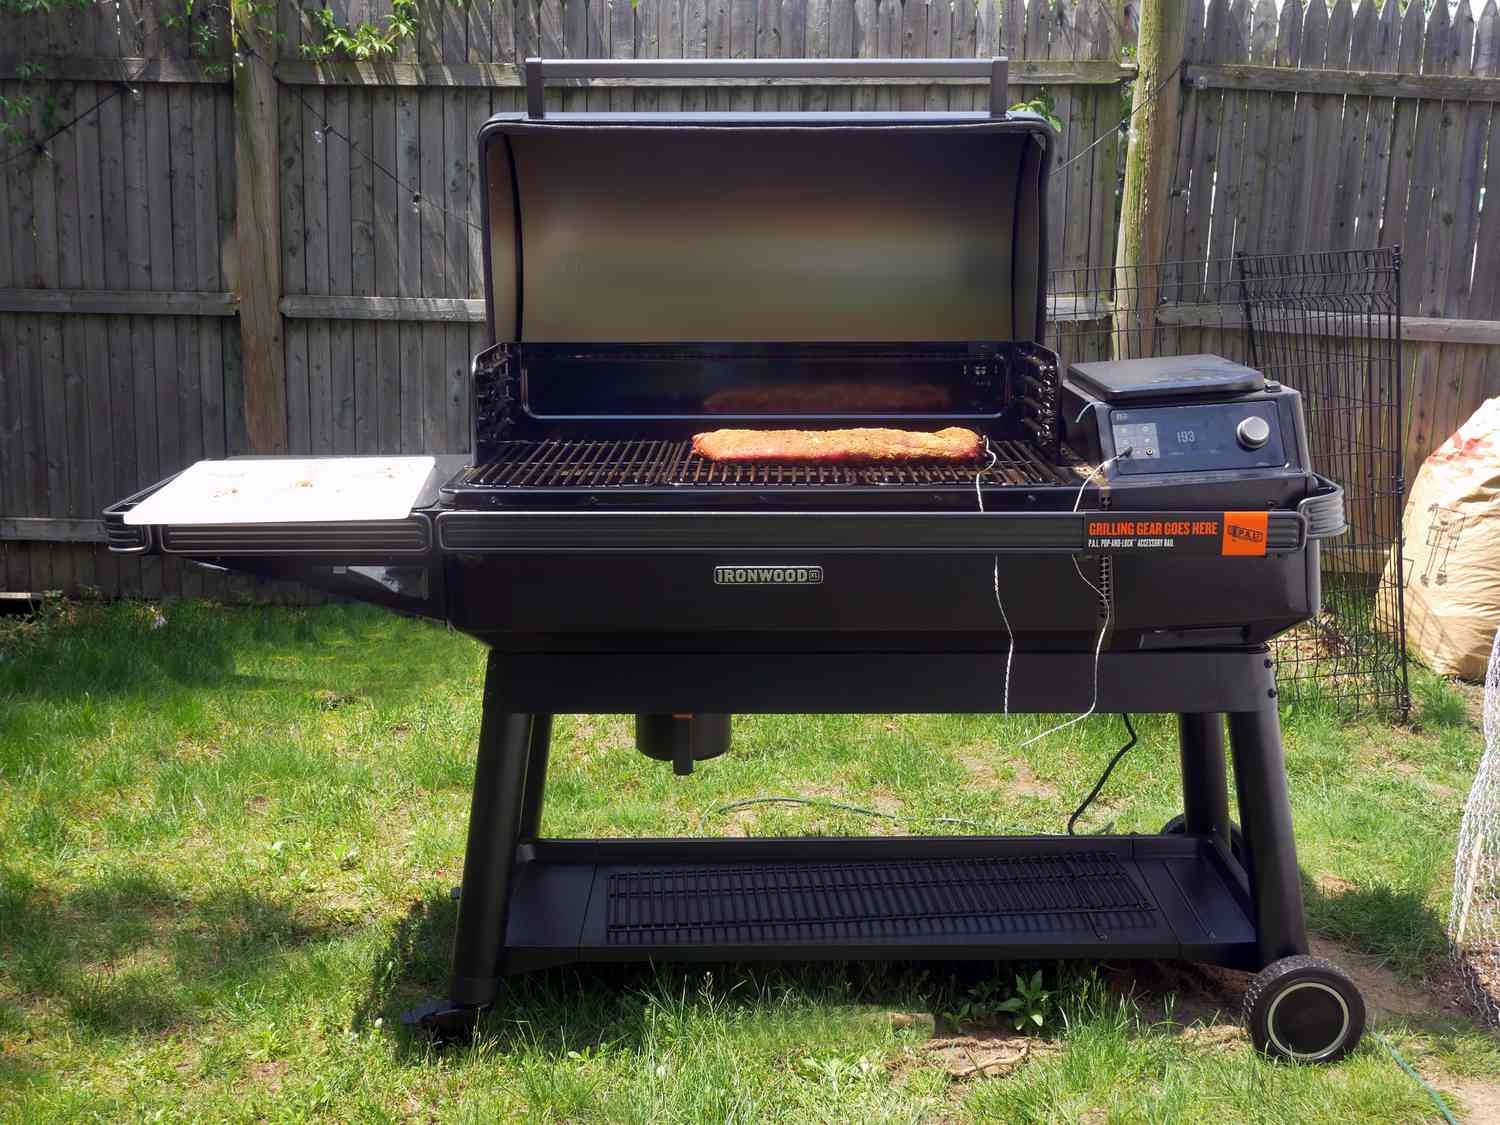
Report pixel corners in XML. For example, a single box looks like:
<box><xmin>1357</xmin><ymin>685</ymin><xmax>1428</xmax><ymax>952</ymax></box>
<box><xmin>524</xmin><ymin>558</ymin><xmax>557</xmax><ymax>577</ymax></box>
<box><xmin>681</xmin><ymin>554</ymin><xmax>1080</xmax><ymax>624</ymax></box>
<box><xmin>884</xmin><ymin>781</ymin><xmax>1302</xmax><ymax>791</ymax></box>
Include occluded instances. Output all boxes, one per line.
<box><xmin>234</xmin><ymin>5</ymin><xmax>287</xmax><ymax>453</ymax></box>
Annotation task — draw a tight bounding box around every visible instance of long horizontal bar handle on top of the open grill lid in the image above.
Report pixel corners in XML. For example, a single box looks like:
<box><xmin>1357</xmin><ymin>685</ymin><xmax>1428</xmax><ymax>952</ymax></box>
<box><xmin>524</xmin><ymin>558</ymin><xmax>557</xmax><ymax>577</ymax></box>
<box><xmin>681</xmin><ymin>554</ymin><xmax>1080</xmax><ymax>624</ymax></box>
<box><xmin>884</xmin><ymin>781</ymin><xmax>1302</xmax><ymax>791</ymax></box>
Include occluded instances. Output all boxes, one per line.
<box><xmin>527</xmin><ymin>59</ymin><xmax>1010</xmax><ymax>119</ymax></box>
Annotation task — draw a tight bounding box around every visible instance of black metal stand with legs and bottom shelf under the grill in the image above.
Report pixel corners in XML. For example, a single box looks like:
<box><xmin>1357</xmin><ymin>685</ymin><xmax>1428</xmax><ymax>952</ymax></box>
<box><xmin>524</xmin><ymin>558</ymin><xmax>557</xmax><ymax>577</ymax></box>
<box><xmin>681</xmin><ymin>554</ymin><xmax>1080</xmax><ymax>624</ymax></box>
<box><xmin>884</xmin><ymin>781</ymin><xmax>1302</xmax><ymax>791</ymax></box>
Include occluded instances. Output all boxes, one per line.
<box><xmin>411</xmin><ymin>648</ymin><xmax>1308</xmax><ymax>1029</ymax></box>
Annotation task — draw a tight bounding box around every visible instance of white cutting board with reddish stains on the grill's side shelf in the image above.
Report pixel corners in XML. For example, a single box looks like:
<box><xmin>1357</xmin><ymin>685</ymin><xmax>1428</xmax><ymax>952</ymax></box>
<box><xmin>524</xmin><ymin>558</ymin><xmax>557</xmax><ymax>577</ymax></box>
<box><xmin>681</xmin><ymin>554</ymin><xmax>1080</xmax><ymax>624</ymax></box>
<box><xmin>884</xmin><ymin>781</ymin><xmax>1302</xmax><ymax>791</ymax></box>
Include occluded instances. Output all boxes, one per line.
<box><xmin>125</xmin><ymin>458</ymin><xmax>434</xmax><ymax>524</ymax></box>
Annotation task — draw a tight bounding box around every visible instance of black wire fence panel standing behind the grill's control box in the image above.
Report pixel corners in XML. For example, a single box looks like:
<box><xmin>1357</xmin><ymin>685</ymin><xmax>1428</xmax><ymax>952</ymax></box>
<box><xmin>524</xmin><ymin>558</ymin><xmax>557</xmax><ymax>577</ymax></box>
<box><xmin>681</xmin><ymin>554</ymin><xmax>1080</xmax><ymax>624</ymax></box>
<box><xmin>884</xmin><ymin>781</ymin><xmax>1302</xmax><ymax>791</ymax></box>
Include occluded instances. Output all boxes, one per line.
<box><xmin>1047</xmin><ymin>249</ymin><xmax>1409</xmax><ymax>716</ymax></box>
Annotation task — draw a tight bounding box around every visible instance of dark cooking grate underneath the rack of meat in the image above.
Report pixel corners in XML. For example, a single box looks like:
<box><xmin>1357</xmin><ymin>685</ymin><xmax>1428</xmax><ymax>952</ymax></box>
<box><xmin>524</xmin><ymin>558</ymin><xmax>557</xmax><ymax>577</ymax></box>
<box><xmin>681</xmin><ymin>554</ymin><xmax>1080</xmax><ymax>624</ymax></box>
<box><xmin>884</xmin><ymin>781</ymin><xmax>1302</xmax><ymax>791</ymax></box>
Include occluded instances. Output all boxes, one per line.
<box><xmin>455</xmin><ymin>440</ymin><xmax>1077</xmax><ymax>489</ymax></box>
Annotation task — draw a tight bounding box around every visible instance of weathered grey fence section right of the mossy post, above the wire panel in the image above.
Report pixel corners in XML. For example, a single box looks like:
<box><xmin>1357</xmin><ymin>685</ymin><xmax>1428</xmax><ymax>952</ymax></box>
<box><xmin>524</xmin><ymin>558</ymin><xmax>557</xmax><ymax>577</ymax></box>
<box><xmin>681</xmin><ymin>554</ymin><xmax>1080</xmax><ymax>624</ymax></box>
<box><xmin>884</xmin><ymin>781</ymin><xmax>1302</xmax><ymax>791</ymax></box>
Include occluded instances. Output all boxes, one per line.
<box><xmin>1163</xmin><ymin>0</ymin><xmax>1500</xmax><ymax>483</ymax></box>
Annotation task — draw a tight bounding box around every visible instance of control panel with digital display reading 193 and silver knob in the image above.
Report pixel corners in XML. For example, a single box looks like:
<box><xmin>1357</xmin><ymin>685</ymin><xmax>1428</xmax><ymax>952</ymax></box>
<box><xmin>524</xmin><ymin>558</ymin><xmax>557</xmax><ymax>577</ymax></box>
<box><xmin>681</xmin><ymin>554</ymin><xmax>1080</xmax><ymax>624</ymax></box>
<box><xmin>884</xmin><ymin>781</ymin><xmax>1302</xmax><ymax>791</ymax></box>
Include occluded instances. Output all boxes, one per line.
<box><xmin>1109</xmin><ymin>402</ymin><xmax>1287</xmax><ymax>476</ymax></box>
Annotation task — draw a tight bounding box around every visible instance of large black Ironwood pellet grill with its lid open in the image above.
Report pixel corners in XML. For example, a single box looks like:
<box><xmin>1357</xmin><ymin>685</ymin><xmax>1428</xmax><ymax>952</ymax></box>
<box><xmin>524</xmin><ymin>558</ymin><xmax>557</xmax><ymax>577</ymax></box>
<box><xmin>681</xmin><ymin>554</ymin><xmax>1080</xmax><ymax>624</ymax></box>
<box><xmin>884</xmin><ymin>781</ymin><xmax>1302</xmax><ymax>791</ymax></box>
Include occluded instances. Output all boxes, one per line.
<box><xmin>105</xmin><ymin>60</ymin><xmax>1364</xmax><ymax>1061</ymax></box>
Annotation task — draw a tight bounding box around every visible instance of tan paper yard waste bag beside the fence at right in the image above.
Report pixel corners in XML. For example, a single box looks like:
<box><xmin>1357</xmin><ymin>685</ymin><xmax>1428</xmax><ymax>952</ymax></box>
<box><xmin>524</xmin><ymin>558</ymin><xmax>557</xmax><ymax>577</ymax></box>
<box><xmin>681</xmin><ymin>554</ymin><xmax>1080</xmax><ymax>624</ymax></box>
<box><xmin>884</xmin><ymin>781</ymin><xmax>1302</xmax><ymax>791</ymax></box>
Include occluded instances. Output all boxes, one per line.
<box><xmin>1379</xmin><ymin>399</ymin><xmax>1500</xmax><ymax>680</ymax></box>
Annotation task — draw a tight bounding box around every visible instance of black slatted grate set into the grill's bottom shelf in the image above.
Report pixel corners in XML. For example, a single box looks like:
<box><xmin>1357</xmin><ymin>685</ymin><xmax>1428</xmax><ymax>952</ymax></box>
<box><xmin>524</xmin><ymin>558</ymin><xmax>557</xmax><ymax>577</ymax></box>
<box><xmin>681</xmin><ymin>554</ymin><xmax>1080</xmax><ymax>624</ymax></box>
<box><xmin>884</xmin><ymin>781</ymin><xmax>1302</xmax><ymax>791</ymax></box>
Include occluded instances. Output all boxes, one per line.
<box><xmin>606</xmin><ymin>852</ymin><xmax>1157</xmax><ymax>945</ymax></box>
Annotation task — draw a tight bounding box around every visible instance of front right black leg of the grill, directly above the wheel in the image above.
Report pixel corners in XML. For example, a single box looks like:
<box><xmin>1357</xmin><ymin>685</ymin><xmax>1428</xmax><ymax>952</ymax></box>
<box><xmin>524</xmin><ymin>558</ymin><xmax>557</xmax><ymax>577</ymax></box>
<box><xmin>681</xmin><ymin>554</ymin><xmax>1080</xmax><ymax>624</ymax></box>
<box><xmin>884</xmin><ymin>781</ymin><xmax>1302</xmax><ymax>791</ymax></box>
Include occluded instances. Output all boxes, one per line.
<box><xmin>1229</xmin><ymin>696</ymin><xmax>1308</xmax><ymax>968</ymax></box>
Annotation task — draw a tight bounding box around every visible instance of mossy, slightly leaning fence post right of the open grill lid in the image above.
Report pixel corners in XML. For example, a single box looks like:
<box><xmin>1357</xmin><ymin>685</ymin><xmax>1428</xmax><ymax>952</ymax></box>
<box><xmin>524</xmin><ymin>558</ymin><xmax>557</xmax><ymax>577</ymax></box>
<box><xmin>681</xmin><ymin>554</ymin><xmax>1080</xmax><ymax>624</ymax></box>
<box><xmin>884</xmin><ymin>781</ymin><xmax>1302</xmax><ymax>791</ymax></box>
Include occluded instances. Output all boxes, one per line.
<box><xmin>1115</xmin><ymin>0</ymin><xmax>1188</xmax><ymax>359</ymax></box>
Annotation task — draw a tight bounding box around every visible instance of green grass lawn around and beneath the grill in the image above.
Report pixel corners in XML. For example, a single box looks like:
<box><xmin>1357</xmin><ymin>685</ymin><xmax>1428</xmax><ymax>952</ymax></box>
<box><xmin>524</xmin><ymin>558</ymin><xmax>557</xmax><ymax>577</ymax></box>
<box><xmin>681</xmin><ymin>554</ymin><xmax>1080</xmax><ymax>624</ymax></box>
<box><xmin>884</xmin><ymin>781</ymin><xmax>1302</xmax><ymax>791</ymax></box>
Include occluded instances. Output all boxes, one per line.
<box><xmin>0</xmin><ymin>603</ymin><xmax>1500</xmax><ymax>1122</ymax></box>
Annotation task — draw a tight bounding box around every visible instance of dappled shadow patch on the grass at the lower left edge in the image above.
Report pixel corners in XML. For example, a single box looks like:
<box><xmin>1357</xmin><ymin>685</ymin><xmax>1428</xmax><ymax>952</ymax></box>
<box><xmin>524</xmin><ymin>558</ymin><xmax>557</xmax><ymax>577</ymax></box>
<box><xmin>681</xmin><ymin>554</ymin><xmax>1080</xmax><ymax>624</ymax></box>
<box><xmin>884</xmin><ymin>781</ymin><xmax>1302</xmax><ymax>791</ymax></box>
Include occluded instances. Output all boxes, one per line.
<box><xmin>0</xmin><ymin>869</ymin><xmax>342</xmax><ymax>1035</ymax></box>
